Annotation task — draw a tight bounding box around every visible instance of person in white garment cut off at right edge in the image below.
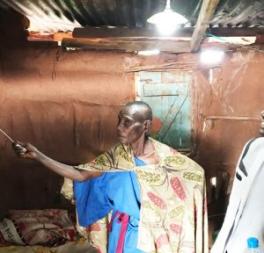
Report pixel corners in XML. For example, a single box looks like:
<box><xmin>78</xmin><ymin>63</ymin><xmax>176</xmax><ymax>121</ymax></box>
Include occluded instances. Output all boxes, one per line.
<box><xmin>211</xmin><ymin>111</ymin><xmax>264</xmax><ymax>253</ymax></box>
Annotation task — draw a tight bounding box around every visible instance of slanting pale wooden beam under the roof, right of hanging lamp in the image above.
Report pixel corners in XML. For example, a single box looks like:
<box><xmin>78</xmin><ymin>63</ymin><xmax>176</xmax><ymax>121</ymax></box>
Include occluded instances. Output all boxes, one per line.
<box><xmin>191</xmin><ymin>0</ymin><xmax>220</xmax><ymax>52</ymax></box>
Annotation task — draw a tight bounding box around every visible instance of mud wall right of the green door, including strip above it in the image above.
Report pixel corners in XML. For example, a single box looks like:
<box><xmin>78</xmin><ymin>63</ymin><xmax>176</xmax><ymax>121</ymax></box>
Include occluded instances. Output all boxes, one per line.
<box><xmin>131</xmin><ymin>49</ymin><xmax>264</xmax><ymax>240</ymax></box>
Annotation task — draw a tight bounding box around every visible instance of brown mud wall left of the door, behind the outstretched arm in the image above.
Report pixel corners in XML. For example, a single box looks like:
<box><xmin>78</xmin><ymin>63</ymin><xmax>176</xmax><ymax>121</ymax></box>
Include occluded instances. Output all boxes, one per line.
<box><xmin>0</xmin><ymin>45</ymin><xmax>134</xmax><ymax>212</ymax></box>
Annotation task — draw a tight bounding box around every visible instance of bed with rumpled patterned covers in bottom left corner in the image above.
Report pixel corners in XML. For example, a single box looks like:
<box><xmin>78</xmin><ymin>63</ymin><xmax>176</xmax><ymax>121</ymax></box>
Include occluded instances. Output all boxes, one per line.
<box><xmin>0</xmin><ymin>209</ymin><xmax>98</xmax><ymax>253</ymax></box>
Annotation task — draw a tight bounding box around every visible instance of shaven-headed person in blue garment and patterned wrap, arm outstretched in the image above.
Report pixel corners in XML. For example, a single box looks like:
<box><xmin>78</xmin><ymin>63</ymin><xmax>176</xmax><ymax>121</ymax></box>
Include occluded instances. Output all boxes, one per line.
<box><xmin>12</xmin><ymin>101</ymin><xmax>207</xmax><ymax>253</ymax></box>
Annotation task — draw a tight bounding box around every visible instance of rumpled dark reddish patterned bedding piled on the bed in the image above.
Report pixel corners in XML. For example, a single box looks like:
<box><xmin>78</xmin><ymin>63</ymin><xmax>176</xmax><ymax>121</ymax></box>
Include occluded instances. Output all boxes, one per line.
<box><xmin>0</xmin><ymin>209</ymin><xmax>76</xmax><ymax>246</ymax></box>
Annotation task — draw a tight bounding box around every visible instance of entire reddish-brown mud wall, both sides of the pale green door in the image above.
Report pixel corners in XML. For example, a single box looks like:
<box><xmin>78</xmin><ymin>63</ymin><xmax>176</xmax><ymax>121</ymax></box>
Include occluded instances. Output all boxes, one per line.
<box><xmin>0</xmin><ymin>42</ymin><xmax>264</xmax><ymax>234</ymax></box>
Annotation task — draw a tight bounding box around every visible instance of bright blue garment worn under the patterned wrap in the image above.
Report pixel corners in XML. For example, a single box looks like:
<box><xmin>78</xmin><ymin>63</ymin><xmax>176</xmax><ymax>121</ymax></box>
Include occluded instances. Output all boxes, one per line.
<box><xmin>74</xmin><ymin>158</ymin><xmax>145</xmax><ymax>253</ymax></box>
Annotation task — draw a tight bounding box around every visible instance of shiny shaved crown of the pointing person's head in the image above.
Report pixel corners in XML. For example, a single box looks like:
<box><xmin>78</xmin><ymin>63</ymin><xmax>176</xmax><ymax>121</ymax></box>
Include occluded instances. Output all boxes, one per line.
<box><xmin>123</xmin><ymin>101</ymin><xmax>152</xmax><ymax>121</ymax></box>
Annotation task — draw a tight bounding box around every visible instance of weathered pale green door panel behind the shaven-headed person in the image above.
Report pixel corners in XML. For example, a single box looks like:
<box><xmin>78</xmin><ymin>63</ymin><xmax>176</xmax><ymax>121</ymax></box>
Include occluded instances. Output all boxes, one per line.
<box><xmin>137</xmin><ymin>72</ymin><xmax>192</xmax><ymax>150</ymax></box>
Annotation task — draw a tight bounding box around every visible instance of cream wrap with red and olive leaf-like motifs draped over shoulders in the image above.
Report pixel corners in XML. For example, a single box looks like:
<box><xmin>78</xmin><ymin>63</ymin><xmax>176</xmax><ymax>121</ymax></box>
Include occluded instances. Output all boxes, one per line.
<box><xmin>60</xmin><ymin>139</ymin><xmax>208</xmax><ymax>253</ymax></box>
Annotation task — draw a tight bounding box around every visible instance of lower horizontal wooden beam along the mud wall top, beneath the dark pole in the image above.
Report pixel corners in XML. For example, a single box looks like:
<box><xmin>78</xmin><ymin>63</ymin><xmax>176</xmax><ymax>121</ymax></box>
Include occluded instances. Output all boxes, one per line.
<box><xmin>62</xmin><ymin>38</ymin><xmax>190</xmax><ymax>53</ymax></box>
